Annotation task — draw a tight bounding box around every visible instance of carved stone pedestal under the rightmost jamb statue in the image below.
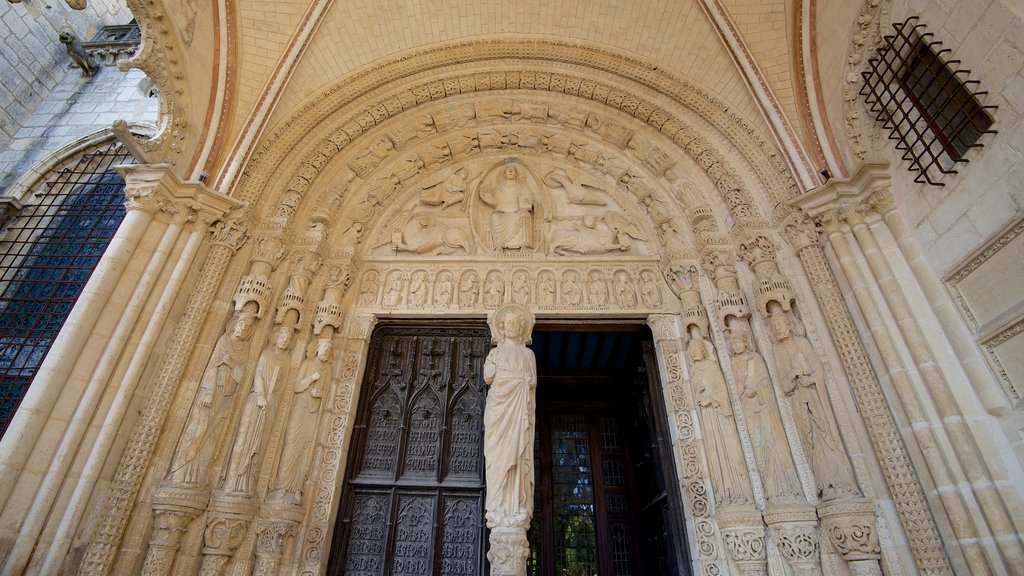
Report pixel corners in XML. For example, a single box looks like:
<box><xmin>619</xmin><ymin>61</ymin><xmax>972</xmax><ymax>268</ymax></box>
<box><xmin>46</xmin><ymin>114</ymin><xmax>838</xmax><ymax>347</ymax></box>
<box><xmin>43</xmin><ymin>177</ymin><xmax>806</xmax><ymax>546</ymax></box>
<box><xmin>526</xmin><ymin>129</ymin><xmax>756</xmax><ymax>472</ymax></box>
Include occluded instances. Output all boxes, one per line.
<box><xmin>818</xmin><ymin>498</ymin><xmax>882</xmax><ymax>576</ymax></box>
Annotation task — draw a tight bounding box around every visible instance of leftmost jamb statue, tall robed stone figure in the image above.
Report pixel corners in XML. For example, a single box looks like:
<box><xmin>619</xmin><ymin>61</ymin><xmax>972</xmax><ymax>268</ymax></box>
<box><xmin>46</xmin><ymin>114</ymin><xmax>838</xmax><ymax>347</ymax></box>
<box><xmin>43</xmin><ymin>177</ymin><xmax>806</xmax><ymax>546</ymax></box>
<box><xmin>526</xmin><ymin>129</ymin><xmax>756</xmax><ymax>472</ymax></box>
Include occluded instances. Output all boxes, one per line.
<box><xmin>168</xmin><ymin>307</ymin><xmax>255</xmax><ymax>485</ymax></box>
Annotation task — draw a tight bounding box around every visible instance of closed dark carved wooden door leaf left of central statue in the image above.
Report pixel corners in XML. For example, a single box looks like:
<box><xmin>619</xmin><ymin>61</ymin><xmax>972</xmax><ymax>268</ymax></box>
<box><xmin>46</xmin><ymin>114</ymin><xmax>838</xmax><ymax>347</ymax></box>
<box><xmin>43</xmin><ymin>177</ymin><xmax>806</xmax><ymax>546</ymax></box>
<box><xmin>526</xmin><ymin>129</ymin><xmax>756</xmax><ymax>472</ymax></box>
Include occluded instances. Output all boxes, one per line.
<box><xmin>328</xmin><ymin>325</ymin><xmax>489</xmax><ymax>576</ymax></box>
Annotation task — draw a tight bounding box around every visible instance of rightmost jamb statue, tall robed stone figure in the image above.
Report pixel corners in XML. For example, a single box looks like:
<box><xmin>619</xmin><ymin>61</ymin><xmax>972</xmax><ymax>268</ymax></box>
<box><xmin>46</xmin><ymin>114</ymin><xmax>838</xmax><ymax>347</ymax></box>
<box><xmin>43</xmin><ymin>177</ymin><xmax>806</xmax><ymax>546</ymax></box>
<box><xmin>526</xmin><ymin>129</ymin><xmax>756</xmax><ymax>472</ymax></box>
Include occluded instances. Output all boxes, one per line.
<box><xmin>768</xmin><ymin>310</ymin><xmax>858</xmax><ymax>500</ymax></box>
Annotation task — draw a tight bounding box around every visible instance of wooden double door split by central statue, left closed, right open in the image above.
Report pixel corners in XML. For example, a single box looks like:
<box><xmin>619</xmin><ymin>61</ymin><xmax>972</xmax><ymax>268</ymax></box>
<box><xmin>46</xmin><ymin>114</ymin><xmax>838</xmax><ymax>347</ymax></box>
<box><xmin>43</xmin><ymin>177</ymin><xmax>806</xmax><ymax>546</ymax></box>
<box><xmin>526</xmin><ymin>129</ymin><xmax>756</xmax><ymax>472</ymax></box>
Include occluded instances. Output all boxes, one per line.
<box><xmin>328</xmin><ymin>324</ymin><xmax>688</xmax><ymax>576</ymax></box>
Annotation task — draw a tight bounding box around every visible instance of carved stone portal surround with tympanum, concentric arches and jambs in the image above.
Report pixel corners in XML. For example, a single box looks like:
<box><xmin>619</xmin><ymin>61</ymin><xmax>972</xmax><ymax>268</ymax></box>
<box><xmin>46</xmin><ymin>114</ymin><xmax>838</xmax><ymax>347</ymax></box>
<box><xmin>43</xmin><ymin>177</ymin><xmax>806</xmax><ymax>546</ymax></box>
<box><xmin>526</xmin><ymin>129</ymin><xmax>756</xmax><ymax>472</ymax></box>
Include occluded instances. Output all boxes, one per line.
<box><xmin>84</xmin><ymin>41</ymin><xmax>941</xmax><ymax>574</ymax></box>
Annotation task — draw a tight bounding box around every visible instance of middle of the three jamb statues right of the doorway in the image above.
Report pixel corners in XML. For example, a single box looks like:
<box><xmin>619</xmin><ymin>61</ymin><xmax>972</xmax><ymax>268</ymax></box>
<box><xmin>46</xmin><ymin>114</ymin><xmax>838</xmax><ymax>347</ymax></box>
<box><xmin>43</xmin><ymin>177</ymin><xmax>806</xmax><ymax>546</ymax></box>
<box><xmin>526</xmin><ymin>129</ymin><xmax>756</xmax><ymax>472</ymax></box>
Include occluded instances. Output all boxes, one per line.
<box><xmin>729</xmin><ymin>328</ymin><xmax>802</xmax><ymax>503</ymax></box>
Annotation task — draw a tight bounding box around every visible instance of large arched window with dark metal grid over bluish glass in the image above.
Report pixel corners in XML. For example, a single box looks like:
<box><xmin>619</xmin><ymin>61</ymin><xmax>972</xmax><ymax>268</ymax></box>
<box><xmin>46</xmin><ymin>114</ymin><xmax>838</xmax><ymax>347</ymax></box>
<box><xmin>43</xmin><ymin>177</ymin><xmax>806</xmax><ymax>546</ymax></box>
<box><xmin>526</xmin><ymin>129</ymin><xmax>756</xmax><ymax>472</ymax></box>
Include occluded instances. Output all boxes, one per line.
<box><xmin>0</xmin><ymin>142</ymin><xmax>134</xmax><ymax>435</ymax></box>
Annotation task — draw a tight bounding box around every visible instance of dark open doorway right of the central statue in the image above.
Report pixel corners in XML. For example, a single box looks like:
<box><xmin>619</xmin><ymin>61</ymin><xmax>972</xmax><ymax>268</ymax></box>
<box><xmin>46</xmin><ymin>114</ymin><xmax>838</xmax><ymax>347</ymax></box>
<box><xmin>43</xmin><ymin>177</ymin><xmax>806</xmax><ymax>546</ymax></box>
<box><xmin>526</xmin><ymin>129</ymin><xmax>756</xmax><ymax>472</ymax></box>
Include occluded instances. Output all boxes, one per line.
<box><xmin>527</xmin><ymin>325</ymin><xmax>689</xmax><ymax>576</ymax></box>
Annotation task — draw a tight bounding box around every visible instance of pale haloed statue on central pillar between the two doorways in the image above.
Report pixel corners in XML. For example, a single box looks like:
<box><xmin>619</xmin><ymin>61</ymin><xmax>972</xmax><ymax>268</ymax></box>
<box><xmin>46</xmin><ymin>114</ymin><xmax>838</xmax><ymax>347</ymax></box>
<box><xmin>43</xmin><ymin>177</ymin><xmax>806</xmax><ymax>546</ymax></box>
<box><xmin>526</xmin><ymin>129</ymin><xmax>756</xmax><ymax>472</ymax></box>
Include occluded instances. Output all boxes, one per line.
<box><xmin>483</xmin><ymin>304</ymin><xmax>537</xmax><ymax>576</ymax></box>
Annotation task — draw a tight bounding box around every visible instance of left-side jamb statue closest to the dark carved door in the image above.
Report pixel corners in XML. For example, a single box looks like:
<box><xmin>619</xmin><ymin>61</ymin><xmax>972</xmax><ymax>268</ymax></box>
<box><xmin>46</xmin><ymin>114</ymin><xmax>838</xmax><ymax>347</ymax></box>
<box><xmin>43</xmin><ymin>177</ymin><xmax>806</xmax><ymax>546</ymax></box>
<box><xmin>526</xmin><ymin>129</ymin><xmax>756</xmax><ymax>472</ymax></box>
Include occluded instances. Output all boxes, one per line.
<box><xmin>274</xmin><ymin>338</ymin><xmax>331</xmax><ymax>503</ymax></box>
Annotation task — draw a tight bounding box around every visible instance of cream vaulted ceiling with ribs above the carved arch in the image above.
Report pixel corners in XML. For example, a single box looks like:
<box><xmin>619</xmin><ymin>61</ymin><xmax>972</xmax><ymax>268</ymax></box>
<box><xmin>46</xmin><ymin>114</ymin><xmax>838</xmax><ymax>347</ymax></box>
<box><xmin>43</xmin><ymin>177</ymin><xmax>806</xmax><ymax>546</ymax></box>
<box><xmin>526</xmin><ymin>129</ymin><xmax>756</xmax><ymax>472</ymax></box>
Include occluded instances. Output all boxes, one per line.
<box><xmin>119</xmin><ymin>0</ymin><xmax>859</xmax><ymax>192</ymax></box>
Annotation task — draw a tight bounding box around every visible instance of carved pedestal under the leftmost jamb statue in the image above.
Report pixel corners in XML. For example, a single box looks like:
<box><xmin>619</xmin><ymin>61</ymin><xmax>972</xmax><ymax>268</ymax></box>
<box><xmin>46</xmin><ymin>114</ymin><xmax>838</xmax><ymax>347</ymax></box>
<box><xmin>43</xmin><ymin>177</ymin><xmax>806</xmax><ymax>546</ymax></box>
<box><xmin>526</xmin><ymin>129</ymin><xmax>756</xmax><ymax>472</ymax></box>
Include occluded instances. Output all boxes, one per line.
<box><xmin>142</xmin><ymin>484</ymin><xmax>210</xmax><ymax>576</ymax></box>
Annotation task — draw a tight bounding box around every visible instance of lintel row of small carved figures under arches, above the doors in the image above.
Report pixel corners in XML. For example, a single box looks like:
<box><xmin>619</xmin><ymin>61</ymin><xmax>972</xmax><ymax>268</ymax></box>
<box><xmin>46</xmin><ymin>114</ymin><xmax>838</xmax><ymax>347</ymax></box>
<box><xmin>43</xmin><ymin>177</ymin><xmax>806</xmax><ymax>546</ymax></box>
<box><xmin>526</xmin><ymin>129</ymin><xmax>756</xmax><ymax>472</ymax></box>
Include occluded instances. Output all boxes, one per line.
<box><xmin>358</xmin><ymin>268</ymin><xmax>662</xmax><ymax>308</ymax></box>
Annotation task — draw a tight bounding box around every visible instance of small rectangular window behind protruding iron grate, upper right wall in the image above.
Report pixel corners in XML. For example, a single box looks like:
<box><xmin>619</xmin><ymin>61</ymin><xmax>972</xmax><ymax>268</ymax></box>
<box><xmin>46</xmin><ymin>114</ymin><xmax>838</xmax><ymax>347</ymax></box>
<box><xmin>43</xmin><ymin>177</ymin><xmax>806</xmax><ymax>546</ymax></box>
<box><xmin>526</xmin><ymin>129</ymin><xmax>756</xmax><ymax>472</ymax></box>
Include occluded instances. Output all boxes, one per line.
<box><xmin>860</xmin><ymin>16</ymin><xmax>996</xmax><ymax>187</ymax></box>
